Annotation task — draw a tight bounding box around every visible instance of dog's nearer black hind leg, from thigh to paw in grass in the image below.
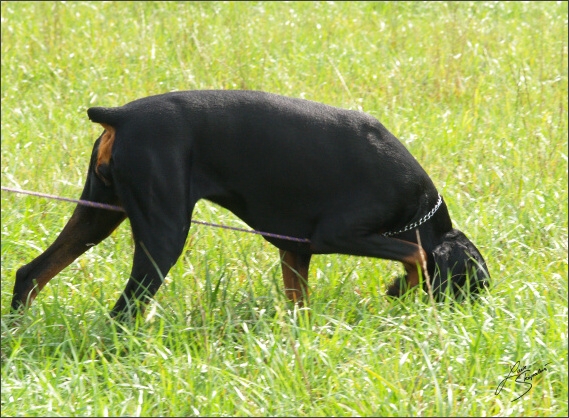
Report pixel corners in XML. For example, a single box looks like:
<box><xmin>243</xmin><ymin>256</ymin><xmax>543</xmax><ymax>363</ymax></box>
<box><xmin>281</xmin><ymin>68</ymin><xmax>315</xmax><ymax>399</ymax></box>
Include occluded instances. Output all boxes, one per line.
<box><xmin>111</xmin><ymin>170</ymin><xmax>194</xmax><ymax>320</ymax></box>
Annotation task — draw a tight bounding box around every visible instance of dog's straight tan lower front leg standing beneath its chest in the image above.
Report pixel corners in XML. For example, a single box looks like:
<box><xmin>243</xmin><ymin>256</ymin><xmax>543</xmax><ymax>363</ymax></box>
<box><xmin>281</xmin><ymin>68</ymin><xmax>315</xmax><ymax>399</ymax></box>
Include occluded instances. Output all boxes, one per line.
<box><xmin>279</xmin><ymin>250</ymin><xmax>311</xmax><ymax>306</ymax></box>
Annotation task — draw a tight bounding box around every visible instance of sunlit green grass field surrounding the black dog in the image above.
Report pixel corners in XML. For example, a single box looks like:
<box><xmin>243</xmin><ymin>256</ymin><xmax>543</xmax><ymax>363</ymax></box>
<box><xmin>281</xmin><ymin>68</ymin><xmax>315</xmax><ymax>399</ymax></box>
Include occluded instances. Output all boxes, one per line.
<box><xmin>1</xmin><ymin>2</ymin><xmax>568</xmax><ymax>416</ymax></box>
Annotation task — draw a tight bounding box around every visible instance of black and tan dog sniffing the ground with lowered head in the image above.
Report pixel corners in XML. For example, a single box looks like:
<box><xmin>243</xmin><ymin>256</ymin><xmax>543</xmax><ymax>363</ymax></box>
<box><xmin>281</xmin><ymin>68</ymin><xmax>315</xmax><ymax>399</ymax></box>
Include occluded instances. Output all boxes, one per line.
<box><xmin>12</xmin><ymin>91</ymin><xmax>489</xmax><ymax>316</ymax></box>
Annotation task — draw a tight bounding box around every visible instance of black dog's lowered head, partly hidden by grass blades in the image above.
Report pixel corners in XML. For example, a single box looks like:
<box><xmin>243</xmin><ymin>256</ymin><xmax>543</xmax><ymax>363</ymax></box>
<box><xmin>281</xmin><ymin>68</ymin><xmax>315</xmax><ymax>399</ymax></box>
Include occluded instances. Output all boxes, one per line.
<box><xmin>425</xmin><ymin>229</ymin><xmax>490</xmax><ymax>300</ymax></box>
